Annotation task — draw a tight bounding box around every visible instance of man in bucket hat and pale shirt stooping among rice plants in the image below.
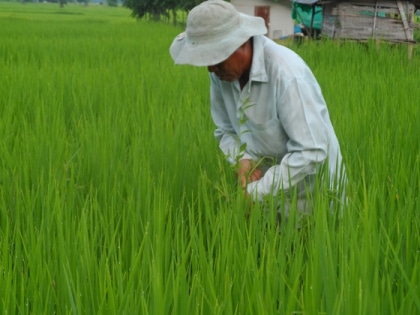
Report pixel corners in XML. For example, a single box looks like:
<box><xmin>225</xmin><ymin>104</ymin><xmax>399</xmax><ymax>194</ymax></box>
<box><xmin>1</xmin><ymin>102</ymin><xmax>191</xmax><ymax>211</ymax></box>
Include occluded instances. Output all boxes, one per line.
<box><xmin>170</xmin><ymin>0</ymin><xmax>345</xmax><ymax>220</ymax></box>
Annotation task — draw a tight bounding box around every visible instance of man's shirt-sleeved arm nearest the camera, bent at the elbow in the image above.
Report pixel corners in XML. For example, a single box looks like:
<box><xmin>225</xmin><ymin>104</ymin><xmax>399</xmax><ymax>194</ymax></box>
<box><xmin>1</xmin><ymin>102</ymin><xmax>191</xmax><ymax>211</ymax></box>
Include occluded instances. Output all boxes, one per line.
<box><xmin>247</xmin><ymin>78</ymin><xmax>330</xmax><ymax>200</ymax></box>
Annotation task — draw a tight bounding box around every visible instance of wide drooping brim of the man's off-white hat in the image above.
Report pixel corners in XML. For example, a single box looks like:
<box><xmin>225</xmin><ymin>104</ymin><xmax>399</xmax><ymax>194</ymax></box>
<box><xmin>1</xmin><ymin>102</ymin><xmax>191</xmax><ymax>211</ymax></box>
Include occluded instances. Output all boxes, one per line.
<box><xmin>169</xmin><ymin>13</ymin><xmax>267</xmax><ymax>66</ymax></box>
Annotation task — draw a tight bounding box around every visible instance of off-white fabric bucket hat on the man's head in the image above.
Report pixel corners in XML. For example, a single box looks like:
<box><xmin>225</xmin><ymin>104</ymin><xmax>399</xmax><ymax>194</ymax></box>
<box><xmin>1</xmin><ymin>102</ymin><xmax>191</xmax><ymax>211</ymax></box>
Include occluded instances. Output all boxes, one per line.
<box><xmin>170</xmin><ymin>0</ymin><xmax>267</xmax><ymax>66</ymax></box>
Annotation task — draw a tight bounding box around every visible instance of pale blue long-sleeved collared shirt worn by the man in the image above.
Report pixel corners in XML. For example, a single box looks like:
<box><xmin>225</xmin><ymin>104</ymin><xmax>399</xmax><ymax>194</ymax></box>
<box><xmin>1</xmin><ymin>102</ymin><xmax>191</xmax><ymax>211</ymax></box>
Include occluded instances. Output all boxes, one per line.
<box><xmin>210</xmin><ymin>35</ymin><xmax>342</xmax><ymax>200</ymax></box>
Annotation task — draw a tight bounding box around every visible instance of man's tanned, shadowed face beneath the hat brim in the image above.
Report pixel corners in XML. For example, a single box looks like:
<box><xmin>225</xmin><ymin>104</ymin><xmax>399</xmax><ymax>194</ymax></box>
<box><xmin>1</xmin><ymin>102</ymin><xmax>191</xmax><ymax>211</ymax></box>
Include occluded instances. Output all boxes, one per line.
<box><xmin>207</xmin><ymin>41</ymin><xmax>249</xmax><ymax>82</ymax></box>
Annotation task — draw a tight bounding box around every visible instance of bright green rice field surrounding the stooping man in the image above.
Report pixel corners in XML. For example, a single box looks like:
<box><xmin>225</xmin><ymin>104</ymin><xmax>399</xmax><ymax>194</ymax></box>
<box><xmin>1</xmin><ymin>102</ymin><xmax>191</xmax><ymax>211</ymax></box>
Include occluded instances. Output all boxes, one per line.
<box><xmin>0</xmin><ymin>2</ymin><xmax>420</xmax><ymax>315</ymax></box>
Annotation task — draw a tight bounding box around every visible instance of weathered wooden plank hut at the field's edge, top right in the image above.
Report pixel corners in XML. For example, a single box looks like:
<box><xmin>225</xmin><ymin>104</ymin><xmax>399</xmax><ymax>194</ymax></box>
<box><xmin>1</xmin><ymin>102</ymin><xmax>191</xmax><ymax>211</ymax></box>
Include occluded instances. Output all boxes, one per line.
<box><xmin>317</xmin><ymin>0</ymin><xmax>420</xmax><ymax>43</ymax></box>
